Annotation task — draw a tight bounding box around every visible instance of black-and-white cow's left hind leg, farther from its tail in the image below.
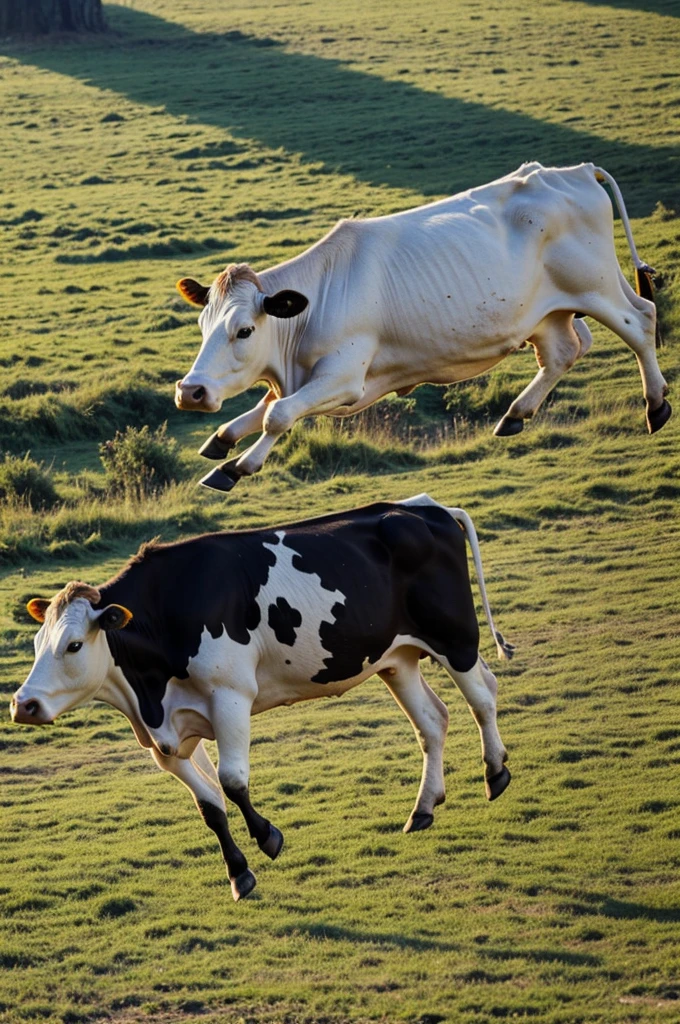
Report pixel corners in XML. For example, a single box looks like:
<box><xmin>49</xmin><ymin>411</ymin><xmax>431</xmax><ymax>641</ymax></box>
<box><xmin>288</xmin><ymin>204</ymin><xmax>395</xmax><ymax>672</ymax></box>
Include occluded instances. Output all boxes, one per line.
<box><xmin>379</xmin><ymin>648</ymin><xmax>449</xmax><ymax>833</ymax></box>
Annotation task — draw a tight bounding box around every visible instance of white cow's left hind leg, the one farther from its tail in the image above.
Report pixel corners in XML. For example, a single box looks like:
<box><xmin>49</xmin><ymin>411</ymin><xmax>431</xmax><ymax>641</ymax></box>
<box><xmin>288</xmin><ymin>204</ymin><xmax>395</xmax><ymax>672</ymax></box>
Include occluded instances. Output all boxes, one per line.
<box><xmin>494</xmin><ymin>311</ymin><xmax>593</xmax><ymax>437</ymax></box>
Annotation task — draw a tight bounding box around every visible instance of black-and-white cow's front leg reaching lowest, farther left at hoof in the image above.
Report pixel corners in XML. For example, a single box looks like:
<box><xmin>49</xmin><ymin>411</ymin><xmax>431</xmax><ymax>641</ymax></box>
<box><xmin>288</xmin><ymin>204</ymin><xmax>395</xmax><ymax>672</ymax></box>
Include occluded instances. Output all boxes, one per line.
<box><xmin>152</xmin><ymin>744</ymin><xmax>255</xmax><ymax>900</ymax></box>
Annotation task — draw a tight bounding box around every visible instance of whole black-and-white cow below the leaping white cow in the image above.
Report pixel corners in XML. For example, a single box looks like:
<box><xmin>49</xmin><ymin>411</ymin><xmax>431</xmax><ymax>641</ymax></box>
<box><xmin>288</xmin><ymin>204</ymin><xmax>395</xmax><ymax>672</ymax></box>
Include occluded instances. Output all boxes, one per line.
<box><xmin>11</xmin><ymin>495</ymin><xmax>512</xmax><ymax>900</ymax></box>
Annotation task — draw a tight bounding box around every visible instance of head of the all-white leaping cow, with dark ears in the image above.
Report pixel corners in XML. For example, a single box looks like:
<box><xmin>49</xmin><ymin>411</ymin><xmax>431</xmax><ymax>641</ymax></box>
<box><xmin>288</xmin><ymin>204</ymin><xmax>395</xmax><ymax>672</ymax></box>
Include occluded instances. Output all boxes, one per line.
<box><xmin>175</xmin><ymin>263</ymin><xmax>308</xmax><ymax>413</ymax></box>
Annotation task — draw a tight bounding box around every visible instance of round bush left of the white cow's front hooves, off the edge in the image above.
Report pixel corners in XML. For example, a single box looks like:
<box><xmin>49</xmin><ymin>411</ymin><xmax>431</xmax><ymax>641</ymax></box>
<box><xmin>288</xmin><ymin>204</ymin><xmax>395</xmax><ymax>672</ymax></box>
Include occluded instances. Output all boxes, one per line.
<box><xmin>99</xmin><ymin>423</ymin><xmax>183</xmax><ymax>500</ymax></box>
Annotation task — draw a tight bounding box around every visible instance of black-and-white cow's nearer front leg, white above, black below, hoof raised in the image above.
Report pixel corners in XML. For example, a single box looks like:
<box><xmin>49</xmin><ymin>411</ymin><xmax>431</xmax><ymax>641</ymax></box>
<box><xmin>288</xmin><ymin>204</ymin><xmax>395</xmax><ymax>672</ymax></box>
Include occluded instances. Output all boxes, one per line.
<box><xmin>212</xmin><ymin>690</ymin><xmax>284</xmax><ymax>860</ymax></box>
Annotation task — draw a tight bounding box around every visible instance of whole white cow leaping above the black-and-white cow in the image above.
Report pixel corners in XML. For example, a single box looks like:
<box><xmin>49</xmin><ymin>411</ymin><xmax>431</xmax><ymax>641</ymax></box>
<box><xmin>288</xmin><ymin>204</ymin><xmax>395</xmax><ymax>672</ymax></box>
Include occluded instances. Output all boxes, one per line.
<box><xmin>175</xmin><ymin>163</ymin><xmax>671</xmax><ymax>490</ymax></box>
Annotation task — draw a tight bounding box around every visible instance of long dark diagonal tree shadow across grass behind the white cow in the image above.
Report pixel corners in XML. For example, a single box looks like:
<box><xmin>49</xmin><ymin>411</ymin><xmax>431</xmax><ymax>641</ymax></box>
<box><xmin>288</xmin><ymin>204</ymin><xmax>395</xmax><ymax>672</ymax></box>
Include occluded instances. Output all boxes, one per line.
<box><xmin>6</xmin><ymin>4</ymin><xmax>680</xmax><ymax>216</ymax></box>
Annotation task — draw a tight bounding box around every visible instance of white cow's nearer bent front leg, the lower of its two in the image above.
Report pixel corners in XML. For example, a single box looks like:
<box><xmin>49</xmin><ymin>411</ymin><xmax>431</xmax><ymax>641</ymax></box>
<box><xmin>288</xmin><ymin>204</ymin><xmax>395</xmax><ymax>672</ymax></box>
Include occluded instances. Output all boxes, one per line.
<box><xmin>201</xmin><ymin>339</ymin><xmax>375</xmax><ymax>490</ymax></box>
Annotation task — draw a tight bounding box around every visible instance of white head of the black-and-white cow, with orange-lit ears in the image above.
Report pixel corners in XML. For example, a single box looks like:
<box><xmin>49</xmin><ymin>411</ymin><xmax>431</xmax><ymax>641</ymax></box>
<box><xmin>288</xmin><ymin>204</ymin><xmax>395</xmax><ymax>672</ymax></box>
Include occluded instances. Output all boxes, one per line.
<box><xmin>10</xmin><ymin>582</ymin><xmax>132</xmax><ymax>725</ymax></box>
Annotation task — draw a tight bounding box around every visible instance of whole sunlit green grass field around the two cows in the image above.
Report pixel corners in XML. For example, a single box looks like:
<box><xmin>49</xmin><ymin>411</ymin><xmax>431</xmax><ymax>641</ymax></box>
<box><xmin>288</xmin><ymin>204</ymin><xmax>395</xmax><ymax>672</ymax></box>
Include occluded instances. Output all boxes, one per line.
<box><xmin>0</xmin><ymin>0</ymin><xmax>680</xmax><ymax>1024</ymax></box>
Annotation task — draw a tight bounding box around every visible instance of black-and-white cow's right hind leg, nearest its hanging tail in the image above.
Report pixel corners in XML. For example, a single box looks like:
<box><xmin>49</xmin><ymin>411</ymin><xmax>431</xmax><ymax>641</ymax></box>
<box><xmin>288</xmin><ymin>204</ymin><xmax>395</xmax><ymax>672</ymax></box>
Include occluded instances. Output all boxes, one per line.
<box><xmin>445</xmin><ymin>657</ymin><xmax>510</xmax><ymax>800</ymax></box>
